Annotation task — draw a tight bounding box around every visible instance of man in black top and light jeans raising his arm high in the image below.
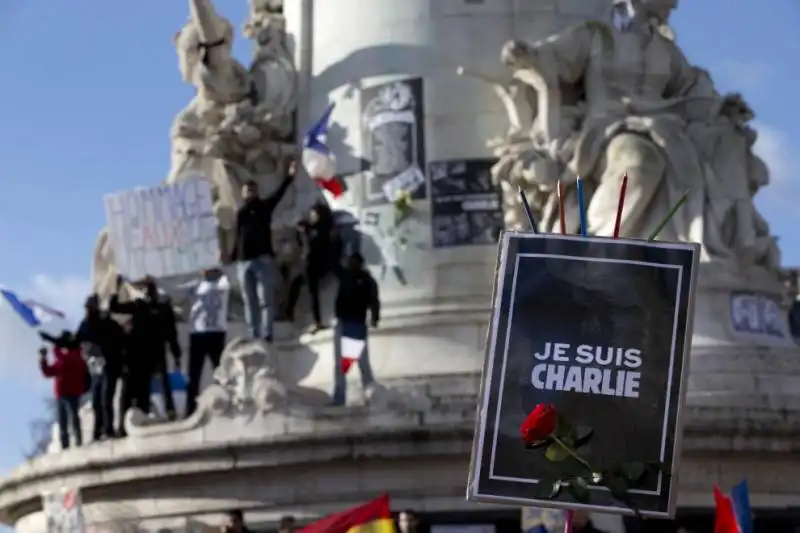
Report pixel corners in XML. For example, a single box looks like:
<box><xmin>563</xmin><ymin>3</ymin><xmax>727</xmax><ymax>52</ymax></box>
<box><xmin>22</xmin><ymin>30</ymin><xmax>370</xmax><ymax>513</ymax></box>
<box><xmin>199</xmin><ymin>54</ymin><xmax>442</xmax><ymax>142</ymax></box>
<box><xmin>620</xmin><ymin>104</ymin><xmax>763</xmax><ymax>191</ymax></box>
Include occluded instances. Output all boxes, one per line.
<box><xmin>227</xmin><ymin>158</ymin><xmax>297</xmax><ymax>342</ymax></box>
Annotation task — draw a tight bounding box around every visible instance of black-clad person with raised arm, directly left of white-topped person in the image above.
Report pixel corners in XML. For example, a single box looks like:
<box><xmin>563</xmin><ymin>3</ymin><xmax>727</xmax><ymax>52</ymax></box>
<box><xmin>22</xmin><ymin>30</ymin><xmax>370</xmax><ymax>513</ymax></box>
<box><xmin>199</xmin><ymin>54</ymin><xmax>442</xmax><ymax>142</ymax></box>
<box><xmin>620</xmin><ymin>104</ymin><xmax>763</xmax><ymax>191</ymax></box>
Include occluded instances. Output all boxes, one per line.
<box><xmin>109</xmin><ymin>276</ymin><xmax>181</xmax><ymax>419</ymax></box>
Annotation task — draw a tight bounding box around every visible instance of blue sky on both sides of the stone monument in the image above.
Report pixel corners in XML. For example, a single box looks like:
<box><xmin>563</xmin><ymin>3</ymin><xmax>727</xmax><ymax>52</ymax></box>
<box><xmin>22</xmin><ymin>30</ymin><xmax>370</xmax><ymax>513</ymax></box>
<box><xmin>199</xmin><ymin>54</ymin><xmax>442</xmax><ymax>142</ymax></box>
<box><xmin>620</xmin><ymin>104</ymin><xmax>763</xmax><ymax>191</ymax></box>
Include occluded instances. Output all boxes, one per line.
<box><xmin>0</xmin><ymin>0</ymin><xmax>800</xmax><ymax>471</ymax></box>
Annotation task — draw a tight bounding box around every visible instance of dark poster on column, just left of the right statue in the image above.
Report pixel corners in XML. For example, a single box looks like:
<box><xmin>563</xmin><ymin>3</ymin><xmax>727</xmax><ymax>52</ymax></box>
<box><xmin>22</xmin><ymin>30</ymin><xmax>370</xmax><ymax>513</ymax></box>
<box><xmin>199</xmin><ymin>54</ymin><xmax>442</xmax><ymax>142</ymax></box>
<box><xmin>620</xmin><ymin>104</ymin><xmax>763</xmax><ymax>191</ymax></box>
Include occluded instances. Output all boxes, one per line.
<box><xmin>428</xmin><ymin>159</ymin><xmax>503</xmax><ymax>248</ymax></box>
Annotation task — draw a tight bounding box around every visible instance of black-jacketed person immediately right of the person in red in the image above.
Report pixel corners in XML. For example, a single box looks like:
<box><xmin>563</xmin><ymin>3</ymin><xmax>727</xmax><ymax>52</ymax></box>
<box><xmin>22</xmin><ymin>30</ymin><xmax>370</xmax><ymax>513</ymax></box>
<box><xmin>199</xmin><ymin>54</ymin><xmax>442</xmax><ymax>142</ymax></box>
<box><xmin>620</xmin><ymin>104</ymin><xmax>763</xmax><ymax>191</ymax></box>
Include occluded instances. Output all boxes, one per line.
<box><xmin>75</xmin><ymin>294</ymin><xmax>124</xmax><ymax>440</ymax></box>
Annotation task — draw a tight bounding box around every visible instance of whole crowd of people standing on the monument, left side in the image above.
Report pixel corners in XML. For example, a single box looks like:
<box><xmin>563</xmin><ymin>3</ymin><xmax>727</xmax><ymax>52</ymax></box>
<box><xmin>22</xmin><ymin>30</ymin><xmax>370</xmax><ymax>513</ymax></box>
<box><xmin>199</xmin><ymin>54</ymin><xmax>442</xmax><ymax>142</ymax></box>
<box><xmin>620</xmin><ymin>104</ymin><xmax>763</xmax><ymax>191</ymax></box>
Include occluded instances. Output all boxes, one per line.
<box><xmin>39</xmin><ymin>161</ymin><xmax>380</xmax><ymax>449</ymax></box>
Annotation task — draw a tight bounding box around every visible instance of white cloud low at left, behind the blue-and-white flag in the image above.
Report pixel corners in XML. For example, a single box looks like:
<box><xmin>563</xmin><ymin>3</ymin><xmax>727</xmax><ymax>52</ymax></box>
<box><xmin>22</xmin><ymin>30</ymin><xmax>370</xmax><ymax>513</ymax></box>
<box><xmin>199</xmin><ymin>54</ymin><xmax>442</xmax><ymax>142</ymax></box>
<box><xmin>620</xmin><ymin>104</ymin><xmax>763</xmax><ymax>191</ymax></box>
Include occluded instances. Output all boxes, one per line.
<box><xmin>0</xmin><ymin>274</ymin><xmax>91</xmax><ymax>383</ymax></box>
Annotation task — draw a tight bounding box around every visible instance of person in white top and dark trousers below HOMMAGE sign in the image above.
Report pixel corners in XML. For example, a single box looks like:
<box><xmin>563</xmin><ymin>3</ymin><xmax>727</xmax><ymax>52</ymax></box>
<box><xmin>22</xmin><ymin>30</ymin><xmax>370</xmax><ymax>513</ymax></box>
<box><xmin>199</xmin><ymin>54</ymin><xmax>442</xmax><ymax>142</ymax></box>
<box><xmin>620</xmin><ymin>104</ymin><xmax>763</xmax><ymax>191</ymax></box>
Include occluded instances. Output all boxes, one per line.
<box><xmin>186</xmin><ymin>268</ymin><xmax>231</xmax><ymax>417</ymax></box>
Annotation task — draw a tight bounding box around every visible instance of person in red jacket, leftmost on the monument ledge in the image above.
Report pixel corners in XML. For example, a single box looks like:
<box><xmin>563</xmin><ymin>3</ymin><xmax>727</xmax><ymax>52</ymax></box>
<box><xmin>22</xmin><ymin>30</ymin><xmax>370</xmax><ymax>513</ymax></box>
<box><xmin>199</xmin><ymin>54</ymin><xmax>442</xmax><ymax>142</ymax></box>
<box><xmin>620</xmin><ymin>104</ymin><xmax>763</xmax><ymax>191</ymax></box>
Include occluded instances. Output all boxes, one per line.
<box><xmin>39</xmin><ymin>331</ymin><xmax>89</xmax><ymax>450</ymax></box>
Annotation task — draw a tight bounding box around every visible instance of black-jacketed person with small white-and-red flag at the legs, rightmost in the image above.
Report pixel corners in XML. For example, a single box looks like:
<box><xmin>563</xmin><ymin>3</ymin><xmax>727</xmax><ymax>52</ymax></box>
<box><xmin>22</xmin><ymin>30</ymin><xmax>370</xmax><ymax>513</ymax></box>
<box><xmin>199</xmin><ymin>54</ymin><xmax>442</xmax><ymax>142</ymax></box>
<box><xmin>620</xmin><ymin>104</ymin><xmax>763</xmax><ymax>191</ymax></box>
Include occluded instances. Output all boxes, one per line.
<box><xmin>332</xmin><ymin>253</ymin><xmax>381</xmax><ymax>405</ymax></box>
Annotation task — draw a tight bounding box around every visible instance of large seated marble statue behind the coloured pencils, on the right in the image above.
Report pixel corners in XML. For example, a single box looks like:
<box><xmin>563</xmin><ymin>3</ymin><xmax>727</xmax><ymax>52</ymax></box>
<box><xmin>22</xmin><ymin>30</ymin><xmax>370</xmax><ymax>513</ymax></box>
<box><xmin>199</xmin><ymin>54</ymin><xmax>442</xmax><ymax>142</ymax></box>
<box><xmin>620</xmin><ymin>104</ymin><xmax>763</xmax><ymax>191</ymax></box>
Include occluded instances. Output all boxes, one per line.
<box><xmin>479</xmin><ymin>0</ymin><xmax>780</xmax><ymax>280</ymax></box>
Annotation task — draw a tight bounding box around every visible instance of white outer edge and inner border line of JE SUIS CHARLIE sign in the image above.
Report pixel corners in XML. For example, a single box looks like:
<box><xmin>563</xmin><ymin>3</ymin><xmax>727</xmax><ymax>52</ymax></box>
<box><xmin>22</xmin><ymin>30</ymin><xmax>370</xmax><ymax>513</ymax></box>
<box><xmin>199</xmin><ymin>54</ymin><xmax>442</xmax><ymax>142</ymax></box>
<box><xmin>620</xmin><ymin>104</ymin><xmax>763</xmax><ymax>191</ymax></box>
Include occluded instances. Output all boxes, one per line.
<box><xmin>467</xmin><ymin>231</ymin><xmax>700</xmax><ymax>518</ymax></box>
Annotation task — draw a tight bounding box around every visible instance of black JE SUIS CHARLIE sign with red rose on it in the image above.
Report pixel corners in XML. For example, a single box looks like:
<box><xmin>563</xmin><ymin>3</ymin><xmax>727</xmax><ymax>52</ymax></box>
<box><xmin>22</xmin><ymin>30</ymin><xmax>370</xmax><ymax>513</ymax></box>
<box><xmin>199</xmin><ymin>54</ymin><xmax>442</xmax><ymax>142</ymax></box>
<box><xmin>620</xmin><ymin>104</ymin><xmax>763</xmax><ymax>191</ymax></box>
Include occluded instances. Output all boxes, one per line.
<box><xmin>467</xmin><ymin>232</ymin><xmax>699</xmax><ymax>517</ymax></box>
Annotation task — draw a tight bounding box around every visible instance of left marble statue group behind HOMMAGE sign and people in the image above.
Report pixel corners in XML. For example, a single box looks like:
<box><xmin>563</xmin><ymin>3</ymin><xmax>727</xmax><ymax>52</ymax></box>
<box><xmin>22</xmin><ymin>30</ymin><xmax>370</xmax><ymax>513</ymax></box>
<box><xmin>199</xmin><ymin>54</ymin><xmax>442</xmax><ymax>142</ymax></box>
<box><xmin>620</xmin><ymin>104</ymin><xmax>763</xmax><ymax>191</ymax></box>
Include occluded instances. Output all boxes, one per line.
<box><xmin>93</xmin><ymin>0</ymin><xmax>319</xmax><ymax>295</ymax></box>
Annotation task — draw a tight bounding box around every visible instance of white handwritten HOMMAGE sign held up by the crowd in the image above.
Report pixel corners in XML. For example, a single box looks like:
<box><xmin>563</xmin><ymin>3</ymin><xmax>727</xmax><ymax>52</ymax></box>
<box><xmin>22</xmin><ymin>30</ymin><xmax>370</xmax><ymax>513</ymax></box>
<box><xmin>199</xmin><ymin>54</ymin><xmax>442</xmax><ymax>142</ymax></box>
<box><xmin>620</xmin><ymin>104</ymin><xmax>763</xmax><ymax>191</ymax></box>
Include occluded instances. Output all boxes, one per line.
<box><xmin>105</xmin><ymin>179</ymin><xmax>219</xmax><ymax>280</ymax></box>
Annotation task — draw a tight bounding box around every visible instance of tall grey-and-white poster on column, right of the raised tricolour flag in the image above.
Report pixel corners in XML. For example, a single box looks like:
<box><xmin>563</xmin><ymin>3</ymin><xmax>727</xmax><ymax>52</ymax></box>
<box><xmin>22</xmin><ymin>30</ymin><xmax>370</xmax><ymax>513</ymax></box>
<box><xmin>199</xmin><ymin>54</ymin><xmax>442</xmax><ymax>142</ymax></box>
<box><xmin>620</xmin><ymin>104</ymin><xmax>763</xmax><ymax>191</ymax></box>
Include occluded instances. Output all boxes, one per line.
<box><xmin>361</xmin><ymin>78</ymin><xmax>427</xmax><ymax>206</ymax></box>
